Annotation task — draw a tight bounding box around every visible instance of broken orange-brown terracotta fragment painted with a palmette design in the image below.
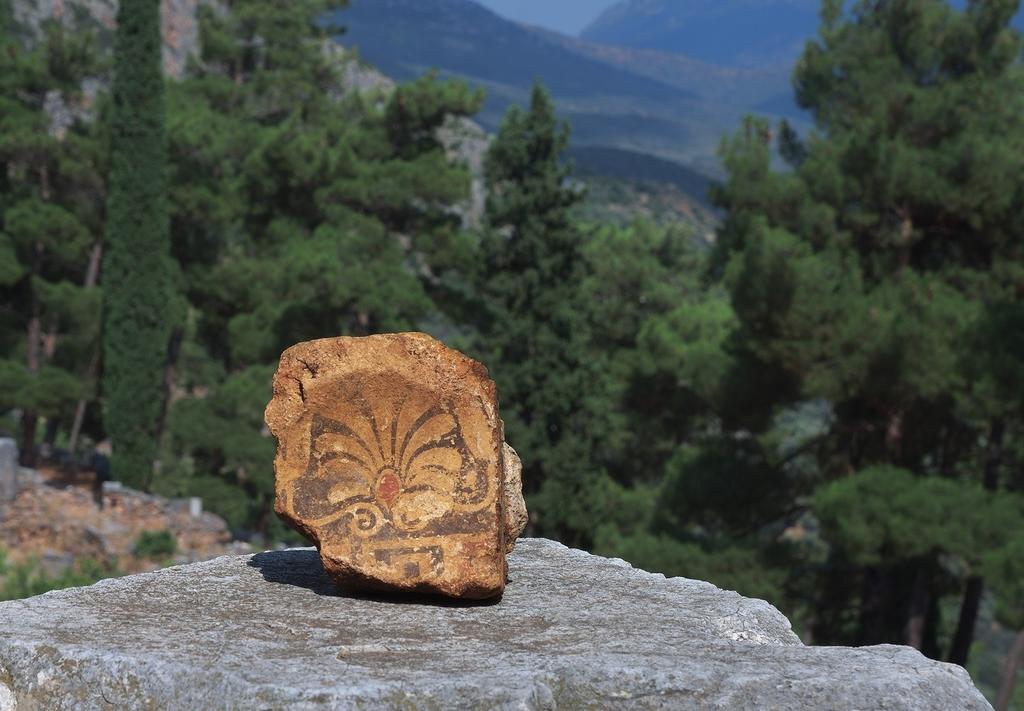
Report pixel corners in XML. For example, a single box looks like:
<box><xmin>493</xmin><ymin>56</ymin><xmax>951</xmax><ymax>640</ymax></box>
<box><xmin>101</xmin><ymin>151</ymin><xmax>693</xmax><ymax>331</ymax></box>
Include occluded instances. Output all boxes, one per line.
<box><xmin>266</xmin><ymin>333</ymin><xmax>526</xmax><ymax>598</ymax></box>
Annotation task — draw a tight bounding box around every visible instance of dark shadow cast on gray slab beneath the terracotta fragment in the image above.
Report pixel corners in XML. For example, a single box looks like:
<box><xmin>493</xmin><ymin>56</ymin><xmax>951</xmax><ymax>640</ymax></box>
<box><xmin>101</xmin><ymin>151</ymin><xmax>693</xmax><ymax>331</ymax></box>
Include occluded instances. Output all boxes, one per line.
<box><xmin>246</xmin><ymin>549</ymin><xmax>501</xmax><ymax>608</ymax></box>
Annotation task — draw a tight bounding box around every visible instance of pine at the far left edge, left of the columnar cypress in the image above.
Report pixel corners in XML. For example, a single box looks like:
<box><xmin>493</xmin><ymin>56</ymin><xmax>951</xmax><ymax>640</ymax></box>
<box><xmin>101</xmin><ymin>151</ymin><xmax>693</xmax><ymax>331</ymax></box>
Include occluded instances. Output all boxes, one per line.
<box><xmin>0</xmin><ymin>18</ymin><xmax>103</xmax><ymax>465</ymax></box>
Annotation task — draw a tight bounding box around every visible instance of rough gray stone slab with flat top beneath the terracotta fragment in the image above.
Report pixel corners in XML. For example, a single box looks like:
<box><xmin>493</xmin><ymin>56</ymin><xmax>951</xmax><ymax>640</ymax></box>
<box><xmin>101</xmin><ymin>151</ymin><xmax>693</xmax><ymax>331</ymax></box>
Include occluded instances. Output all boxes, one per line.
<box><xmin>0</xmin><ymin>539</ymin><xmax>989</xmax><ymax>711</ymax></box>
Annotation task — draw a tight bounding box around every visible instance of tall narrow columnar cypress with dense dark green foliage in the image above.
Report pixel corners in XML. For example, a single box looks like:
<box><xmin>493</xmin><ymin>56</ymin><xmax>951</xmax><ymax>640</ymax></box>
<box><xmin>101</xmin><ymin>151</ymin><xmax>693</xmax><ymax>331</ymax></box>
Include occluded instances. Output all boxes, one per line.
<box><xmin>103</xmin><ymin>0</ymin><xmax>171</xmax><ymax>488</ymax></box>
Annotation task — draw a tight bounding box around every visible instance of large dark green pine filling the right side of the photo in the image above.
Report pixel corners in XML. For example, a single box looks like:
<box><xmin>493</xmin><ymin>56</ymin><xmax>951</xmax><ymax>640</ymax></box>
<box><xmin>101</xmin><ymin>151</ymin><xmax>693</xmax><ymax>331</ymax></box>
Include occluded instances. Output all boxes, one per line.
<box><xmin>714</xmin><ymin>0</ymin><xmax>1024</xmax><ymax>663</ymax></box>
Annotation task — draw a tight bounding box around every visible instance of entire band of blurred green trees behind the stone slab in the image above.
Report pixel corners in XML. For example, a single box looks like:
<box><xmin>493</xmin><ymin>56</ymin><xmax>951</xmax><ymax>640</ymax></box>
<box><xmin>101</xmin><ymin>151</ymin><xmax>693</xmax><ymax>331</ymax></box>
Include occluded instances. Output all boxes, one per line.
<box><xmin>0</xmin><ymin>0</ymin><xmax>1024</xmax><ymax>708</ymax></box>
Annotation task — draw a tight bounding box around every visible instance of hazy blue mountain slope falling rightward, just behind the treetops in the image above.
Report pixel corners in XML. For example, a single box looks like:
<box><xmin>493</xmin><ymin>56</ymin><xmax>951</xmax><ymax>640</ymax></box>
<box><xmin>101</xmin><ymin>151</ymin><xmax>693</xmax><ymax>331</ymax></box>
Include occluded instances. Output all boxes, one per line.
<box><xmin>338</xmin><ymin>0</ymin><xmax>802</xmax><ymax>181</ymax></box>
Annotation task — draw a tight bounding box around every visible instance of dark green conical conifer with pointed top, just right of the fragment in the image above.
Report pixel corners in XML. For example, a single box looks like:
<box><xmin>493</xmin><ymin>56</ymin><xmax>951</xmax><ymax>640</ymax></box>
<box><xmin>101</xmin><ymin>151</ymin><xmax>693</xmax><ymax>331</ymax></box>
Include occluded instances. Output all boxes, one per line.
<box><xmin>476</xmin><ymin>80</ymin><xmax>602</xmax><ymax>543</ymax></box>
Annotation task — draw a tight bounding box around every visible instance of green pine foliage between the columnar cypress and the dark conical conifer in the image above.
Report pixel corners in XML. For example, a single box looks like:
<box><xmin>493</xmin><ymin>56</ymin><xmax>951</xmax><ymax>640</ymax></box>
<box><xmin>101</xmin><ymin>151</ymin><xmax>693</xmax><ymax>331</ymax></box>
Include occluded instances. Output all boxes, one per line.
<box><xmin>156</xmin><ymin>0</ymin><xmax>481</xmax><ymax>536</ymax></box>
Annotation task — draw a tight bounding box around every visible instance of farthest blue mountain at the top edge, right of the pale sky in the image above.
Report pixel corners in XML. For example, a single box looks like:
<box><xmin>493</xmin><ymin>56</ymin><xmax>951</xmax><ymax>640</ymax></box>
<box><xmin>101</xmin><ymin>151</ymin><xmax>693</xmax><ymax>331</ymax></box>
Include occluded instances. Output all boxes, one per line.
<box><xmin>581</xmin><ymin>0</ymin><xmax>821</xmax><ymax>68</ymax></box>
